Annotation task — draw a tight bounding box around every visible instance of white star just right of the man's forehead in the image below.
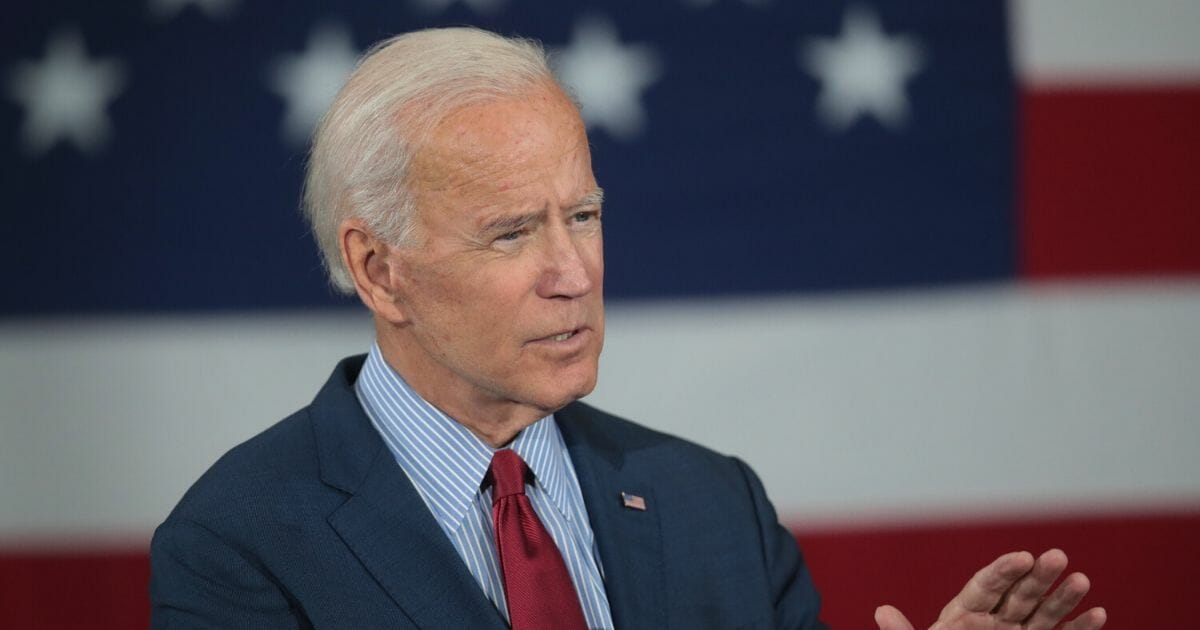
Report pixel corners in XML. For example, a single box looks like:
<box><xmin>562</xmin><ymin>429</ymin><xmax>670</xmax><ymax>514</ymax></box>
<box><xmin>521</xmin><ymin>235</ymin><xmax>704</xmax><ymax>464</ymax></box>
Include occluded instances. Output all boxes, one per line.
<box><xmin>552</xmin><ymin>17</ymin><xmax>660</xmax><ymax>140</ymax></box>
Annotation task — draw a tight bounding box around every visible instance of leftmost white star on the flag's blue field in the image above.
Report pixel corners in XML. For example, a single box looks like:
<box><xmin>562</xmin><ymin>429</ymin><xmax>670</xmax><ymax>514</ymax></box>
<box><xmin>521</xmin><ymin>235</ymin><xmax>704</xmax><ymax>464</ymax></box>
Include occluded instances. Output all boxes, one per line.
<box><xmin>8</xmin><ymin>30</ymin><xmax>125</xmax><ymax>156</ymax></box>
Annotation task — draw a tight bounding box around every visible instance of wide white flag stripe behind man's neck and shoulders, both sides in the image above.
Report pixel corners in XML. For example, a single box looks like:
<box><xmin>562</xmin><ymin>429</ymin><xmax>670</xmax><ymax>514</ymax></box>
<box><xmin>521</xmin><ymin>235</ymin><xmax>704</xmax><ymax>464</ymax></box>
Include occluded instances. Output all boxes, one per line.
<box><xmin>0</xmin><ymin>283</ymin><xmax>1200</xmax><ymax>540</ymax></box>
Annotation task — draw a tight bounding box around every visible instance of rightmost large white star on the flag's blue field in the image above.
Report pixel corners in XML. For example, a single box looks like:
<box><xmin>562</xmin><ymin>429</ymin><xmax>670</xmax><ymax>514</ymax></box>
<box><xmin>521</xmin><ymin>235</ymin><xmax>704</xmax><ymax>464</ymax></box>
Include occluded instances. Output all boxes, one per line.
<box><xmin>797</xmin><ymin>7</ymin><xmax>923</xmax><ymax>131</ymax></box>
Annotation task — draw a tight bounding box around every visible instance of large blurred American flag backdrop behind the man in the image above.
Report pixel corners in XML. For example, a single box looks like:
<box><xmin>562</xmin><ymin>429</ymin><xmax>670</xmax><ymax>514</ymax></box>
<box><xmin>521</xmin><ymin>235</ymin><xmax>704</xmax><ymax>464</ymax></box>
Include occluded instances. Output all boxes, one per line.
<box><xmin>0</xmin><ymin>0</ymin><xmax>1200</xmax><ymax>629</ymax></box>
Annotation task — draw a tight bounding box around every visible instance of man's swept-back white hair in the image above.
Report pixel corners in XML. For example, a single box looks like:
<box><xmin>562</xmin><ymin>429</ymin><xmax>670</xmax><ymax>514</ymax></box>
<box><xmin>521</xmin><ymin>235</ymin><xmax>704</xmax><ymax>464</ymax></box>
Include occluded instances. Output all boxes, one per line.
<box><xmin>304</xmin><ymin>28</ymin><xmax>554</xmax><ymax>294</ymax></box>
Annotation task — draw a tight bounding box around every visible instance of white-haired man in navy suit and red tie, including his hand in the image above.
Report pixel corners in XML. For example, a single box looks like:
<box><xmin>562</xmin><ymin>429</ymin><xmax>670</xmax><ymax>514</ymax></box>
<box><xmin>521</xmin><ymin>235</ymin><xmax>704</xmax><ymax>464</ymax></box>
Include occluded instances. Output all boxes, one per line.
<box><xmin>151</xmin><ymin>29</ymin><xmax>1104</xmax><ymax>630</ymax></box>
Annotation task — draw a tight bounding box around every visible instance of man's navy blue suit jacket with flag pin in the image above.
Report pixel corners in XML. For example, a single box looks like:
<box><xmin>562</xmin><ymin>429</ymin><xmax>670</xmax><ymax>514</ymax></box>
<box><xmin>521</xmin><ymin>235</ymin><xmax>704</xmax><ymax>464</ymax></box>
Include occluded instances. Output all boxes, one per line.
<box><xmin>150</xmin><ymin>356</ymin><xmax>821</xmax><ymax>630</ymax></box>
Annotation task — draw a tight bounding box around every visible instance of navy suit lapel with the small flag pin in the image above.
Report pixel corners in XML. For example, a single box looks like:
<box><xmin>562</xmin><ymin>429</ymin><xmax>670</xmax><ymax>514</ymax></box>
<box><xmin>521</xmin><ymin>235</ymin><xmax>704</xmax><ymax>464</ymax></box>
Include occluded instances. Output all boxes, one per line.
<box><xmin>554</xmin><ymin>403</ymin><xmax>666</xmax><ymax>628</ymax></box>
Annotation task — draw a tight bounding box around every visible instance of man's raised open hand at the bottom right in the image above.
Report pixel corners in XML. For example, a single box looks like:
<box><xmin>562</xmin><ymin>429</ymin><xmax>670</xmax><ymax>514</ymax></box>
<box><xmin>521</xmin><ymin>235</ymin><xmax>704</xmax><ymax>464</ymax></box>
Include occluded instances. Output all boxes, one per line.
<box><xmin>875</xmin><ymin>550</ymin><xmax>1108</xmax><ymax>630</ymax></box>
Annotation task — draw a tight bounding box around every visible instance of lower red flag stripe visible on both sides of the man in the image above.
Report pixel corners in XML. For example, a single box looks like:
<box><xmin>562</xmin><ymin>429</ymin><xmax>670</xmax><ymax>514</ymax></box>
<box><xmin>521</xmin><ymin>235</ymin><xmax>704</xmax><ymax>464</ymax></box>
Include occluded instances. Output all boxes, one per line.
<box><xmin>0</xmin><ymin>511</ymin><xmax>1200</xmax><ymax>630</ymax></box>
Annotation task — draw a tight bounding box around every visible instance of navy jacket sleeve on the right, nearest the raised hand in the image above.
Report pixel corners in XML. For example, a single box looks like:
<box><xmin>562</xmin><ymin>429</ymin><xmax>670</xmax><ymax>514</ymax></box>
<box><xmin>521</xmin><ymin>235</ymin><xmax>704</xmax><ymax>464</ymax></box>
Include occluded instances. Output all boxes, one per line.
<box><xmin>733</xmin><ymin>457</ymin><xmax>826</xmax><ymax>630</ymax></box>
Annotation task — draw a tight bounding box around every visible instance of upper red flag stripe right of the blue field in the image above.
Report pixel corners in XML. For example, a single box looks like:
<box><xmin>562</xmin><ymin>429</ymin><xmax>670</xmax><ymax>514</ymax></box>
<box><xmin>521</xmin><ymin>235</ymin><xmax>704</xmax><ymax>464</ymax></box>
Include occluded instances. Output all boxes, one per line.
<box><xmin>1020</xmin><ymin>85</ymin><xmax>1200</xmax><ymax>277</ymax></box>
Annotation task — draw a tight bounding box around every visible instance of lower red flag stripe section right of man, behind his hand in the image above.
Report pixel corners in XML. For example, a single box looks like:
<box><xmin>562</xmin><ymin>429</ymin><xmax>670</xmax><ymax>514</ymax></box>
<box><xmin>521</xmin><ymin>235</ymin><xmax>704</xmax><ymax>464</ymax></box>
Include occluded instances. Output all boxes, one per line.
<box><xmin>797</xmin><ymin>512</ymin><xmax>1200</xmax><ymax>628</ymax></box>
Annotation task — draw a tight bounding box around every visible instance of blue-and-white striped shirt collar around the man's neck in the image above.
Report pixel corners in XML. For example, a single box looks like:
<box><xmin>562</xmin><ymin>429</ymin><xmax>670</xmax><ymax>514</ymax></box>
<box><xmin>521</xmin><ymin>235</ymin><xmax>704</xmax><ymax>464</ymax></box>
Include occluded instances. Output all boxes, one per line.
<box><xmin>354</xmin><ymin>343</ymin><xmax>571</xmax><ymax>532</ymax></box>
